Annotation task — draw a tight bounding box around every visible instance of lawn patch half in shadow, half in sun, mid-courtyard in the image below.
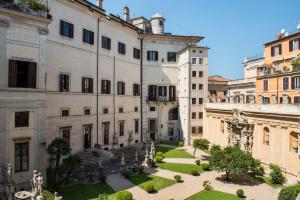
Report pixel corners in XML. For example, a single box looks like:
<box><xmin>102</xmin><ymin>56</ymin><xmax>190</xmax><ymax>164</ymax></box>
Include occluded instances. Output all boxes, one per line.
<box><xmin>128</xmin><ymin>173</ymin><xmax>176</xmax><ymax>191</ymax></box>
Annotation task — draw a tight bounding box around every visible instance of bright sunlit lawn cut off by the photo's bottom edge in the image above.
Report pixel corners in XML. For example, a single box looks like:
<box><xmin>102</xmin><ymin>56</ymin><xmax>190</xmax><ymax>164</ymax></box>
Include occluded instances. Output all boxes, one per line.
<box><xmin>186</xmin><ymin>190</ymin><xmax>241</xmax><ymax>200</ymax></box>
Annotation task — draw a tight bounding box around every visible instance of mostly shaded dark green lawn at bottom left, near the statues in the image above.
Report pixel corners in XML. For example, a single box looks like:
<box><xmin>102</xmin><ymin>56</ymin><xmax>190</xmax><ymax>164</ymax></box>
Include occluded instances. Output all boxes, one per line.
<box><xmin>54</xmin><ymin>183</ymin><xmax>115</xmax><ymax>200</ymax></box>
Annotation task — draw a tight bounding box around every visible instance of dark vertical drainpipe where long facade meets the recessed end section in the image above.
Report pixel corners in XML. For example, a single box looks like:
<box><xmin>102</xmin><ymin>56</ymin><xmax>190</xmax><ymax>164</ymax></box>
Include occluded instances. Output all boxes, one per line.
<box><xmin>139</xmin><ymin>34</ymin><xmax>144</xmax><ymax>142</ymax></box>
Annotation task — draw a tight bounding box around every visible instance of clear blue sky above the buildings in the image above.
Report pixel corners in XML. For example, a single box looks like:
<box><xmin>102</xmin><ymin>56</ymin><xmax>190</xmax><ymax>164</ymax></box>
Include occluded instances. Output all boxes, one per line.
<box><xmin>90</xmin><ymin>0</ymin><xmax>300</xmax><ymax>79</ymax></box>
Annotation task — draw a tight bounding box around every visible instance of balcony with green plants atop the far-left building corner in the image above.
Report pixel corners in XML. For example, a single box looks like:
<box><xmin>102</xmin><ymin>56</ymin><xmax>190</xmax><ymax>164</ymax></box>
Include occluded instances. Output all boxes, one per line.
<box><xmin>0</xmin><ymin>0</ymin><xmax>52</xmax><ymax>19</ymax></box>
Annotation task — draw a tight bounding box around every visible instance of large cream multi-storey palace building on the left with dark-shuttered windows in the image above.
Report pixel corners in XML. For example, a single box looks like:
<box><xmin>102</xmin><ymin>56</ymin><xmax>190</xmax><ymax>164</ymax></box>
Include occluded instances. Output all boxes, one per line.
<box><xmin>0</xmin><ymin>0</ymin><xmax>208</xmax><ymax>191</ymax></box>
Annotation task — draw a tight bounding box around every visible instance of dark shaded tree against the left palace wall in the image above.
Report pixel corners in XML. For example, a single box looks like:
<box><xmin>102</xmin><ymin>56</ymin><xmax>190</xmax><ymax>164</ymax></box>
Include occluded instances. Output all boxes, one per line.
<box><xmin>47</xmin><ymin>138</ymin><xmax>71</xmax><ymax>168</ymax></box>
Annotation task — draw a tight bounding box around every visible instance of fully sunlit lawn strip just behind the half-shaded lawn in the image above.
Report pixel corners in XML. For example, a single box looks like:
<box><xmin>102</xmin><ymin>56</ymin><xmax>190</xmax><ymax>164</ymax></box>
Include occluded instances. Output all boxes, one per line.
<box><xmin>157</xmin><ymin>163</ymin><xmax>203</xmax><ymax>174</ymax></box>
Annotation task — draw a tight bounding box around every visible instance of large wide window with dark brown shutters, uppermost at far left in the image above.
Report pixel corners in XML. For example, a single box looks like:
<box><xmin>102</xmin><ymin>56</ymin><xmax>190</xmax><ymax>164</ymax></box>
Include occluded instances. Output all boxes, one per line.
<box><xmin>8</xmin><ymin>60</ymin><xmax>37</xmax><ymax>88</ymax></box>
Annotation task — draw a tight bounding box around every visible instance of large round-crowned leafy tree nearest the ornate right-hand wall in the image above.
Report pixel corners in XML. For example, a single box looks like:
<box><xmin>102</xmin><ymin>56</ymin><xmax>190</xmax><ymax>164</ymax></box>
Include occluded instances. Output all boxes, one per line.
<box><xmin>209</xmin><ymin>146</ymin><xmax>255</xmax><ymax>181</ymax></box>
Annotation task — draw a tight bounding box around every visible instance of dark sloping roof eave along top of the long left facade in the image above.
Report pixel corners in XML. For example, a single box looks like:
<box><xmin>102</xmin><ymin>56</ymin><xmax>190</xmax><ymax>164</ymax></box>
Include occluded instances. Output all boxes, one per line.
<box><xmin>70</xmin><ymin>0</ymin><xmax>143</xmax><ymax>33</ymax></box>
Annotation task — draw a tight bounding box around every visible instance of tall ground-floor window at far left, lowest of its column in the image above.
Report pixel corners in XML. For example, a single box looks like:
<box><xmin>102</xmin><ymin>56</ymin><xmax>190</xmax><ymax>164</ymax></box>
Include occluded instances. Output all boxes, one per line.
<box><xmin>15</xmin><ymin>142</ymin><xmax>29</xmax><ymax>172</ymax></box>
